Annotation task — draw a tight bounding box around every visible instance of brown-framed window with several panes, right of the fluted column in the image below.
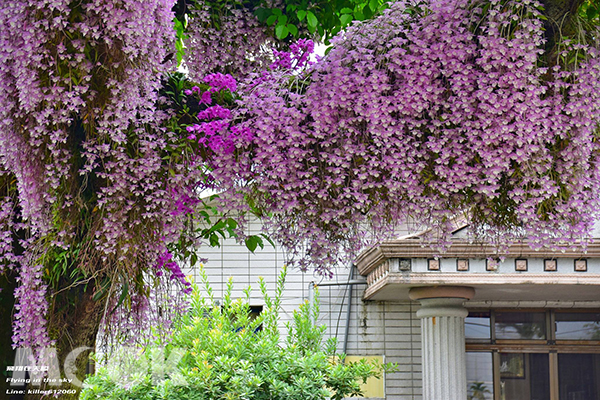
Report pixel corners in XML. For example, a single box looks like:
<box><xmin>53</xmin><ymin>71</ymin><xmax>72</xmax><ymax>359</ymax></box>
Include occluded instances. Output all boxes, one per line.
<box><xmin>465</xmin><ymin>310</ymin><xmax>600</xmax><ymax>400</ymax></box>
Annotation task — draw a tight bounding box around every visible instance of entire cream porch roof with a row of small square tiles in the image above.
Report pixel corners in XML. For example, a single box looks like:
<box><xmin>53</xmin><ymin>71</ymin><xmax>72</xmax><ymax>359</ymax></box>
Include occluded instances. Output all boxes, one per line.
<box><xmin>355</xmin><ymin>237</ymin><xmax>600</xmax><ymax>301</ymax></box>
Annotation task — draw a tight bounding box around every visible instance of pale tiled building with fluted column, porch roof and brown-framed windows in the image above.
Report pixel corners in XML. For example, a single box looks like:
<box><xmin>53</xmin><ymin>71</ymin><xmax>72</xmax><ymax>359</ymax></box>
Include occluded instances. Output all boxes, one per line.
<box><xmin>199</xmin><ymin>220</ymin><xmax>600</xmax><ymax>400</ymax></box>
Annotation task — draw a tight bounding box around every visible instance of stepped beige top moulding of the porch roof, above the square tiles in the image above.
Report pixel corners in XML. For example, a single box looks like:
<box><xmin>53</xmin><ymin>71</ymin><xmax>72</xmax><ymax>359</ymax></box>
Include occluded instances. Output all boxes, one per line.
<box><xmin>354</xmin><ymin>239</ymin><xmax>600</xmax><ymax>276</ymax></box>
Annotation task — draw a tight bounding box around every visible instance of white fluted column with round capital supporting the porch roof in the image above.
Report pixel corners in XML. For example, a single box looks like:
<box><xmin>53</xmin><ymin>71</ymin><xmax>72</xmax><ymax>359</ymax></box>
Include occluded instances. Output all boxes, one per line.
<box><xmin>410</xmin><ymin>286</ymin><xmax>475</xmax><ymax>400</ymax></box>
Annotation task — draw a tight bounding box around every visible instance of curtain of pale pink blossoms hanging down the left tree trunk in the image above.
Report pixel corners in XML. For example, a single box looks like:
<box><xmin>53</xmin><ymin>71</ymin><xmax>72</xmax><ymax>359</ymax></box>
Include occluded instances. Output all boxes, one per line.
<box><xmin>0</xmin><ymin>0</ymin><xmax>200</xmax><ymax>347</ymax></box>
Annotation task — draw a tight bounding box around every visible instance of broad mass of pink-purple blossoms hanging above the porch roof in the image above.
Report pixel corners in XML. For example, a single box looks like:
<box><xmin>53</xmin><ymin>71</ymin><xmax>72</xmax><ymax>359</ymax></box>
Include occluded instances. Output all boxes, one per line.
<box><xmin>210</xmin><ymin>0</ymin><xmax>600</xmax><ymax>273</ymax></box>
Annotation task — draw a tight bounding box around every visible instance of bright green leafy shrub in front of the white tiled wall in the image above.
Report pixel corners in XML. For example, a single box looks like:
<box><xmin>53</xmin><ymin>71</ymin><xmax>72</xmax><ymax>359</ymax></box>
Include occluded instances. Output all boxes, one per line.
<box><xmin>81</xmin><ymin>270</ymin><xmax>392</xmax><ymax>400</ymax></box>
